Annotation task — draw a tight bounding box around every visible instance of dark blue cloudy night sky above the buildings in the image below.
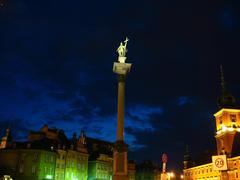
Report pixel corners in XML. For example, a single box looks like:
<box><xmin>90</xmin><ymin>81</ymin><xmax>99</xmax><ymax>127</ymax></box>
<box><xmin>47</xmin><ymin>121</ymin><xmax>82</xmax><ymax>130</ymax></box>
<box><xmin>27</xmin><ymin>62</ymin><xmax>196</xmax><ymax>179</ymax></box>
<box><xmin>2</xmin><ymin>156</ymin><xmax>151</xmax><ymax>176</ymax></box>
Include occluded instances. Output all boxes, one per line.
<box><xmin>0</xmin><ymin>0</ymin><xmax>240</xmax><ymax>169</ymax></box>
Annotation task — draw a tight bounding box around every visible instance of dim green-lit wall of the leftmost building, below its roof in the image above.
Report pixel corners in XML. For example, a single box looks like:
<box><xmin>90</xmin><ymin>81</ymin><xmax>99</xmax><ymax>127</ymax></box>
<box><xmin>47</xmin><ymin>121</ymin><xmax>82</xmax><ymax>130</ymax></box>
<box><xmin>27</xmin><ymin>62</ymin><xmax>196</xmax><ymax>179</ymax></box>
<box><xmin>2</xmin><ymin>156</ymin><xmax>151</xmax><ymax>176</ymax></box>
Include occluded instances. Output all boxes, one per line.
<box><xmin>0</xmin><ymin>149</ymin><xmax>57</xmax><ymax>180</ymax></box>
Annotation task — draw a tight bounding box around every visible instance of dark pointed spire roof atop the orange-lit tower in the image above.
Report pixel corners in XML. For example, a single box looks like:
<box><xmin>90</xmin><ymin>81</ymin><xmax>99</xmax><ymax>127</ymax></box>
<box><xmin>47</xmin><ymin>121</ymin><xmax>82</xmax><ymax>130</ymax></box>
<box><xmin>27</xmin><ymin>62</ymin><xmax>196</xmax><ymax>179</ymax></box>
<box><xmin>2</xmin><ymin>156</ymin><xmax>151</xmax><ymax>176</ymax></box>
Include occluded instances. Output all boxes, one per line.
<box><xmin>217</xmin><ymin>66</ymin><xmax>236</xmax><ymax>110</ymax></box>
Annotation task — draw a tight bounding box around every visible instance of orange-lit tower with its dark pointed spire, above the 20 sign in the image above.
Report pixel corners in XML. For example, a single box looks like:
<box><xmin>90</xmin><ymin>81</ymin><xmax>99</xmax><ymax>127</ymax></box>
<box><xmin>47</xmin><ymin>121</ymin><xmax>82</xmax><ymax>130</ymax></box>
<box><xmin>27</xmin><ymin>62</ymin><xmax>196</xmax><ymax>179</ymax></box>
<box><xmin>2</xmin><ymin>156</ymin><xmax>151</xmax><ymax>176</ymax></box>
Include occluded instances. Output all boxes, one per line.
<box><xmin>214</xmin><ymin>66</ymin><xmax>240</xmax><ymax>157</ymax></box>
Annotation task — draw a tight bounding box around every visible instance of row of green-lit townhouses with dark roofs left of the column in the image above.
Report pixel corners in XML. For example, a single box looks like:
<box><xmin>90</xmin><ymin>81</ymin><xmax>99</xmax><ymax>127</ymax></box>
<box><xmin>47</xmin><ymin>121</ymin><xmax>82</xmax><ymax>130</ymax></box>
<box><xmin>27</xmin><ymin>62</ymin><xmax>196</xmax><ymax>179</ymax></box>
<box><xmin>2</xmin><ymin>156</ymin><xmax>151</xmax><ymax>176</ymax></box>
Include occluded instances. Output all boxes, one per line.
<box><xmin>0</xmin><ymin>125</ymin><xmax>135</xmax><ymax>180</ymax></box>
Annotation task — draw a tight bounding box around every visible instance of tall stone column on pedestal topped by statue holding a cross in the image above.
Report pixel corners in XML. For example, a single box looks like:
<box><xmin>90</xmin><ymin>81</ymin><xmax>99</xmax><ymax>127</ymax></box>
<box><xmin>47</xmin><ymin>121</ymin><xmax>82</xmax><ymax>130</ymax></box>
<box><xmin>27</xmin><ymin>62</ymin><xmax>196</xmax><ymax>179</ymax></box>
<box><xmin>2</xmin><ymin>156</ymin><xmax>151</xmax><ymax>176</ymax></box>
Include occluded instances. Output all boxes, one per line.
<box><xmin>113</xmin><ymin>38</ymin><xmax>131</xmax><ymax>180</ymax></box>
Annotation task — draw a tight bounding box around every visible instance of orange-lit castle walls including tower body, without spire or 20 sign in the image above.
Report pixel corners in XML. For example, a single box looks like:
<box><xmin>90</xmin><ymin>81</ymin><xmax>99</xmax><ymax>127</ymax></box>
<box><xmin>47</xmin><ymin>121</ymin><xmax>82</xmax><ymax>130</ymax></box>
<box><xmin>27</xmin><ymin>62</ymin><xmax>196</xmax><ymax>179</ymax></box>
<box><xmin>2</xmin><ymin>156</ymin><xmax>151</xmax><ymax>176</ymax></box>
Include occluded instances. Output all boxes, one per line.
<box><xmin>184</xmin><ymin>108</ymin><xmax>240</xmax><ymax>180</ymax></box>
